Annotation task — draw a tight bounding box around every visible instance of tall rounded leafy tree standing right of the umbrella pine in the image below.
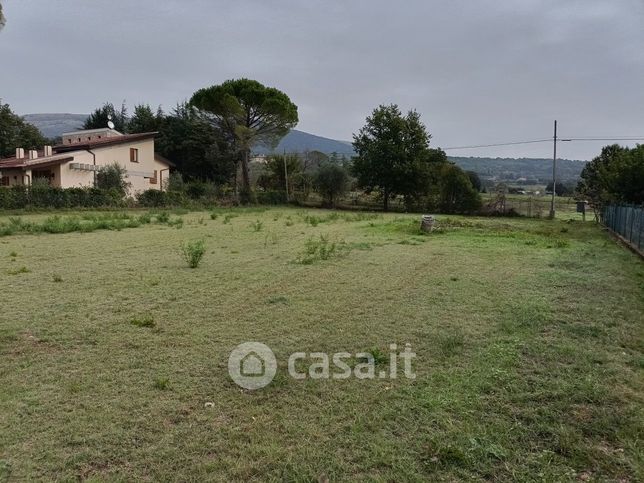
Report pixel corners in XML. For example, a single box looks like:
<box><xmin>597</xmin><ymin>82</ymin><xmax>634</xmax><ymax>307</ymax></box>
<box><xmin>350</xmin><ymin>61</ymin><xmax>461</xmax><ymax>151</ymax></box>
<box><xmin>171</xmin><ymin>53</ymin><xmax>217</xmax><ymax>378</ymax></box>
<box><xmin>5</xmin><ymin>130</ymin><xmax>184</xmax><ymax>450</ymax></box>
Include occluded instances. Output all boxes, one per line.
<box><xmin>353</xmin><ymin>104</ymin><xmax>435</xmax><ymax>211</ymax></box>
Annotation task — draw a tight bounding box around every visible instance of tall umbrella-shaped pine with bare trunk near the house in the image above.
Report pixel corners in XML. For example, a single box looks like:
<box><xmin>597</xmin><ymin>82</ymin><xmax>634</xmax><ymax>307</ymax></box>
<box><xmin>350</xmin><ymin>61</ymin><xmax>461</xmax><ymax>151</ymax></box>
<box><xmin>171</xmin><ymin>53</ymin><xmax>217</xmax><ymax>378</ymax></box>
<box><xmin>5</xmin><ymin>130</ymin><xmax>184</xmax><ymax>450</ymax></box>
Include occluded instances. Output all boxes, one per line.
<box><xmin>190</xmin><ymin>79</ymin><xmax>298</xmax><ymax>201</ymax></box>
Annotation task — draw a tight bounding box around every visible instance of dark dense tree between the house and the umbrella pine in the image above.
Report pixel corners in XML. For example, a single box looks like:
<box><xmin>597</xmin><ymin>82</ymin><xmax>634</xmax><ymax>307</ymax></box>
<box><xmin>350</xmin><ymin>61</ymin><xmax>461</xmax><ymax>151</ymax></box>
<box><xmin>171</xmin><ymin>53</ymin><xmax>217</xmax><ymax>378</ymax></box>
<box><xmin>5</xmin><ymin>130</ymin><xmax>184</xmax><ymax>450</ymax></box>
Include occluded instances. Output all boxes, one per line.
<box><xmin>155</xmin><ymin>103</ymin><xmax>239</xmax><ymax>184</ymax></box>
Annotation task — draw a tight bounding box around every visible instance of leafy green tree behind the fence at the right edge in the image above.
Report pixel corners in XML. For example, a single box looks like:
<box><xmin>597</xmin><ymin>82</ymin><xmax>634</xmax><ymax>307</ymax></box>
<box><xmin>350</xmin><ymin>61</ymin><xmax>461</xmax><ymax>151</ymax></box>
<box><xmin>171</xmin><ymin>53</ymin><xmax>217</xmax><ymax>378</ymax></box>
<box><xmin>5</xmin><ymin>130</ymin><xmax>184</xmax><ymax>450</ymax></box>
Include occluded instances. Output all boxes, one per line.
<box><xmin>577</xmin><ymin>144</ymin><xmax>644</xmax><ymax>211</ymax></box>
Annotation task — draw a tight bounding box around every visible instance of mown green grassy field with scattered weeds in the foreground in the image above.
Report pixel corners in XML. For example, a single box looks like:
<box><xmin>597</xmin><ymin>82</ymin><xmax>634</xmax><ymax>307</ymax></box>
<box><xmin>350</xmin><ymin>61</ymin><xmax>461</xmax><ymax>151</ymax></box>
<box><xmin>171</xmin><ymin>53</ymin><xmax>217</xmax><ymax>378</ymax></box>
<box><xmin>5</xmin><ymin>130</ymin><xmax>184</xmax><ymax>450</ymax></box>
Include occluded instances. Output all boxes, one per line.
<box><xmin>0</xmin><ymin>208</ymin><xmax>644</xmax><ymax>482</ymax></box>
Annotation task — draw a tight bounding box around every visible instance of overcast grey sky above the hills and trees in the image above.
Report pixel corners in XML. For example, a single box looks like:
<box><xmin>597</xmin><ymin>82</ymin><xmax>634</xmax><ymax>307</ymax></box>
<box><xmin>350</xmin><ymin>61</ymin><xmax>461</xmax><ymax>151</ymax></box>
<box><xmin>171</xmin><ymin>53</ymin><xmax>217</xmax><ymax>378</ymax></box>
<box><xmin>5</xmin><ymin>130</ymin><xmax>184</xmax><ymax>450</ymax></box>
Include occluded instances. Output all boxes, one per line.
<box><xmin>0</xmin><ymin>0</ymin><xmax>644</xmax><ymax>159</ymax></box>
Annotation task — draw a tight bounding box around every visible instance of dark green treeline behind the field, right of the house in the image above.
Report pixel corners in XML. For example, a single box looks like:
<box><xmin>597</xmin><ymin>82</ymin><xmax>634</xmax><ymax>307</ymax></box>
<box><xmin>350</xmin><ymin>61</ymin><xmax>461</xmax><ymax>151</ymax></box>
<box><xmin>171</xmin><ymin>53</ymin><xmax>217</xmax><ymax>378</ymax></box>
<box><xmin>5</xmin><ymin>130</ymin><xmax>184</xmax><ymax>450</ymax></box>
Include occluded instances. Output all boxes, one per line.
<box><xmin>84</xmin><ymin>96</ymin><xmax>482</xmax><ymax>213</ymax></box>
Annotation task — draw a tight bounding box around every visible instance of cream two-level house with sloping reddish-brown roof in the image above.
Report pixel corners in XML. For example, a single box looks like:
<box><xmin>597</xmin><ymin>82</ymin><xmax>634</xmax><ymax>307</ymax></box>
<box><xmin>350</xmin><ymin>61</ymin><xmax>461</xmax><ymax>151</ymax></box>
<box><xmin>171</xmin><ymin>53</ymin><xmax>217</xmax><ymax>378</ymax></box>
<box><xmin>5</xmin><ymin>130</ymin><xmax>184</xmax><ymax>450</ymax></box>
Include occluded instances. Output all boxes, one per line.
<box><xmin>0</xmin><ymin>128</ymin><xmax>171</xmax><ymax>193</ymax></box>
